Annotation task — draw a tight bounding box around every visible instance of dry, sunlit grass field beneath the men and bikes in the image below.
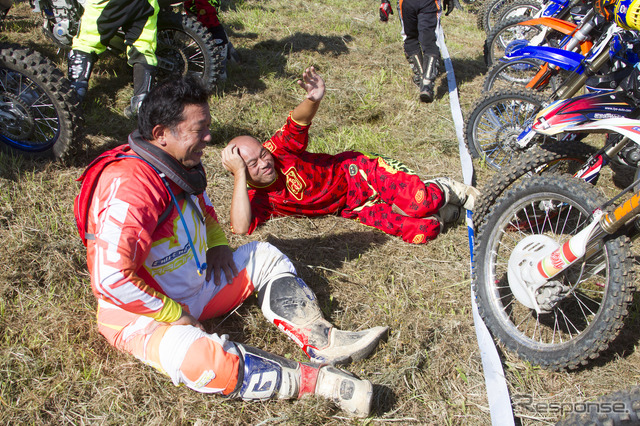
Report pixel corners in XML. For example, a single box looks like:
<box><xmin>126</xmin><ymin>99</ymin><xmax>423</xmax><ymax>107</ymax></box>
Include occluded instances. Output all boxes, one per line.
<box><xmin>0</xmin><ymin>0</ymin><xmax>640</xmax><ymax>425</ymax></box>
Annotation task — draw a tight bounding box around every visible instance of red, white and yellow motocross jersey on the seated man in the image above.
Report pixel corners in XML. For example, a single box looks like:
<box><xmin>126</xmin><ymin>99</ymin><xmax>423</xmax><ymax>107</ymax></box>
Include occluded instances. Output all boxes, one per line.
<box><xmin>87</xmin><ymin>150</ymin><xmax>228</xmax><ymax>322</ymax></box>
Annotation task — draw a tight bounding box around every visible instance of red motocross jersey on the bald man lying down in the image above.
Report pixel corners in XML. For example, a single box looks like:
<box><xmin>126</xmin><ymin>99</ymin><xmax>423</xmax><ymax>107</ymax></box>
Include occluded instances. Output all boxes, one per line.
<box><xmin>244</xmin><ymin>116</ymin><xmax>361</xmax><ymax>233</ymax></box>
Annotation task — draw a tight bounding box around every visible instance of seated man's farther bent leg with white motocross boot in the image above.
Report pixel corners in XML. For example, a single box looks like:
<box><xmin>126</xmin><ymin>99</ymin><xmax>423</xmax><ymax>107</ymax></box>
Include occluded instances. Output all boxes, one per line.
<box><xmin>198</xmin><ymin>242</ymin><xmax>388</xmax><ymax>364</ymax></box>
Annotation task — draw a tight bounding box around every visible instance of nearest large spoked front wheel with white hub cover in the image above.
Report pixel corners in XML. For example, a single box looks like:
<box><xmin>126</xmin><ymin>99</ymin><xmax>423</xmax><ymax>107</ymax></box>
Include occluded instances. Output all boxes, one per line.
<box><xmin>472</xmin><ymin>175</ymin><xmax>633</xmax><ymax>370</ymax></box>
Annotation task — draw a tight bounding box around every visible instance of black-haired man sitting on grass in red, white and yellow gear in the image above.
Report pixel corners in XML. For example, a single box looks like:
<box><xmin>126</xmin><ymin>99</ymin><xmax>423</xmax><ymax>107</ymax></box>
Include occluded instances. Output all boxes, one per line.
<box><xmin>75</xmin><ymin>78</ymin><xmax>387</xmax><ymax>417</ymax></box>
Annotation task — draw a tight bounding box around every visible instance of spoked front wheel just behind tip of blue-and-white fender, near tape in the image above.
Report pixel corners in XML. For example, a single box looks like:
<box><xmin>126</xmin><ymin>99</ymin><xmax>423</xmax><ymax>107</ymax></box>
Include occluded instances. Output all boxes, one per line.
<box><xmin>465</xmin><ymin>89</ymin><xmax>546</xmax><ymax>170</ymax></box>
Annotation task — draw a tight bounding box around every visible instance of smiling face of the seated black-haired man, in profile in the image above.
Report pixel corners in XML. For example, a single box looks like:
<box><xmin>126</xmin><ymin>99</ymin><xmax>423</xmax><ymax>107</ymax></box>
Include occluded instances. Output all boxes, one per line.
<box><xmin>164</xmin><ymin>104</ymin><xmax>211</xmax><ymax>169</ymax></box>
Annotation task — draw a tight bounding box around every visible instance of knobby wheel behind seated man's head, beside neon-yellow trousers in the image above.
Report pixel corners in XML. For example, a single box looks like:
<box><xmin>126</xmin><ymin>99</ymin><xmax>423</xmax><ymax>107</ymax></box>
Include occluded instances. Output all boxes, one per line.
<box><xmin>156</xmin><ymin>9</ymin><xmax>226</xmax><ymax>90</ymax></box>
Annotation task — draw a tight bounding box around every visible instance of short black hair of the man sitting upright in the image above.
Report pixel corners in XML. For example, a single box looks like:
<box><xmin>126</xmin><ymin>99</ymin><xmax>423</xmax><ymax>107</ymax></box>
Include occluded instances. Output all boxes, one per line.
<box><xmin>138</xmin><ymin>75</ymin><xmax>209</xmax><ymax>141</ymax></box>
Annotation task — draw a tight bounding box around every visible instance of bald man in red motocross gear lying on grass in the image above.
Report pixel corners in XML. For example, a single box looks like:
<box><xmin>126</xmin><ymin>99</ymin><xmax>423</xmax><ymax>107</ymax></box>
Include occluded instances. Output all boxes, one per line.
<box><xmin>222</xmin><ymin>67</ymin><xmax>479</xmax><ymax>244</ymax></box>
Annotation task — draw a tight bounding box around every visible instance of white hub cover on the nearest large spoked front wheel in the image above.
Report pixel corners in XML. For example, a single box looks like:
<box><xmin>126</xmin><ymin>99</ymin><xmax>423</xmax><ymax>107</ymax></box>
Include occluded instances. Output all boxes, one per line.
<box><xmin>507</xmin><ymin>234</ymin><xmax>563</xmax><ymax>313</ymax></box>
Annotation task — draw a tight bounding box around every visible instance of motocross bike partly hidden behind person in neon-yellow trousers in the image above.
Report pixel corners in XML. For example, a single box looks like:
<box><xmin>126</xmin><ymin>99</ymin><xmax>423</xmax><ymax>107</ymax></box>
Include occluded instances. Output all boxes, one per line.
<box><xmin>30</xmin><ymin>0</ymin><xmax>226</xmax><ymax>90</ymax></box>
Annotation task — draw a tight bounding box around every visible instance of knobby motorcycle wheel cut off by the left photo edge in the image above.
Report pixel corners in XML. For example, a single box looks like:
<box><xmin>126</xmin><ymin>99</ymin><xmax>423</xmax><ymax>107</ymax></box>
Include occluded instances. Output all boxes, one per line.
<box><xmin>0</xmin><ymin>47</ymin><xmax>78</xmax><ymax>159</ymax></box>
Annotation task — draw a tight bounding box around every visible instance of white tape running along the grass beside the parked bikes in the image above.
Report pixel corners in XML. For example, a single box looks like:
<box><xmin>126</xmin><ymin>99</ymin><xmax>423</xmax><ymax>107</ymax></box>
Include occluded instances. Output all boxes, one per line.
<box><xmin>436</xmin><ymin>19</ymin><xmax>514</xmax><ymax>426</ymax></box>
